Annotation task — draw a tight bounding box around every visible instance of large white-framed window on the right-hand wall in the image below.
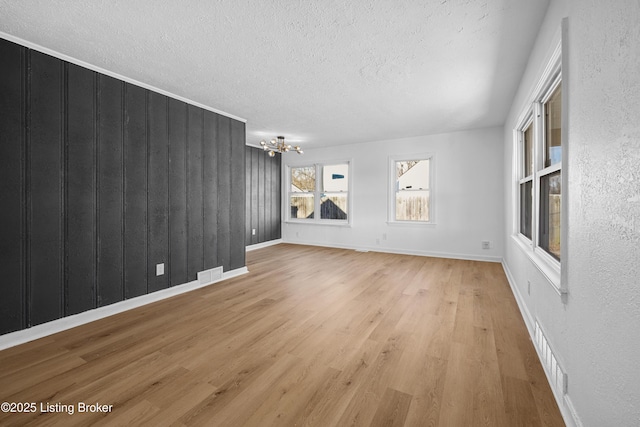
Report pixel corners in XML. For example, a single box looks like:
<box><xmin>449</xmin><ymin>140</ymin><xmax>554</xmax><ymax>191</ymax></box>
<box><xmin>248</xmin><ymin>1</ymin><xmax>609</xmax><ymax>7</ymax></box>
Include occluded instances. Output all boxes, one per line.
<box><xmin>515</xmin><ymin>41</ymin><xmax>566</xmax><ymax>286</ymax></box>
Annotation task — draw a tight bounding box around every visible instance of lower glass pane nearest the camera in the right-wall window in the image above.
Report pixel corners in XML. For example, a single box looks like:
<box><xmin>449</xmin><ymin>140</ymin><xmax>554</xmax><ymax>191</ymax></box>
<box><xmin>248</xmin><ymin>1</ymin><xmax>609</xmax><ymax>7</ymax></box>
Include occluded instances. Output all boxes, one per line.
<box><xmin>540</xmin><ymin>171</ymin><xmax>562</xmax><ymax>261</ymax></box>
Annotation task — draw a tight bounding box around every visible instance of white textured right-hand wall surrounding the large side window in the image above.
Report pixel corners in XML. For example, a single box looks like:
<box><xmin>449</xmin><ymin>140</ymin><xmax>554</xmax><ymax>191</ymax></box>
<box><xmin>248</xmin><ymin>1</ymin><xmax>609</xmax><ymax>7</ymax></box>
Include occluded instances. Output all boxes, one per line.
<box><xmin>504</xmin><ymin>0</ymin><xmax>640</xmax><ymax>426</ymax></box>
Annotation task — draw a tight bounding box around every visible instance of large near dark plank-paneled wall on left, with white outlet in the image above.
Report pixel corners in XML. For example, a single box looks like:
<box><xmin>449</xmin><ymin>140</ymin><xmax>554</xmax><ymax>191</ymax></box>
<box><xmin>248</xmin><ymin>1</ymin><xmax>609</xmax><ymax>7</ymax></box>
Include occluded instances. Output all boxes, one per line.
<box><xmin>0</xmin><ymin>40</ymin><xmax>246</xmax><ymax>334</ymax></box>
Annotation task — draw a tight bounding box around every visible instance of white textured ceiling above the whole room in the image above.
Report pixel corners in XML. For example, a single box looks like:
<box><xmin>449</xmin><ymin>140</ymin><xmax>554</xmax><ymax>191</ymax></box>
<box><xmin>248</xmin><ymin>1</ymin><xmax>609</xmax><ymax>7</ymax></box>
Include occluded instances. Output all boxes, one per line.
<box><xmin>0</xmin><ymin>0</ymin><xmax>549</xmax><ymax>148</ymax></box>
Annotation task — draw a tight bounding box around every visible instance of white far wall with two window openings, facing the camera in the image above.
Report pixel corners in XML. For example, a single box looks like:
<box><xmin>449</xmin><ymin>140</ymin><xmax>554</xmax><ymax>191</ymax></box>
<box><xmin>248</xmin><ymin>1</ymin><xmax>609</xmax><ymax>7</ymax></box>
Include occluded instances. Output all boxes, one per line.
<box><xmin>282</xmin><ymin>128</ymin><xmax>504</xmax><ymax>261</ymax></box>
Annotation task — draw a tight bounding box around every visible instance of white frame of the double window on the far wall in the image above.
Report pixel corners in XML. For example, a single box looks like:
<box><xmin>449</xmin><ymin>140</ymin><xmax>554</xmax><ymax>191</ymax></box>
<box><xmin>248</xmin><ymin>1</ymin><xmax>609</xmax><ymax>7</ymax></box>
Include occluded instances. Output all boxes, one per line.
<box><xmin>283</xmin><ymin>159</ymin><xmax>353</xmax><ymax>227</ymax></box>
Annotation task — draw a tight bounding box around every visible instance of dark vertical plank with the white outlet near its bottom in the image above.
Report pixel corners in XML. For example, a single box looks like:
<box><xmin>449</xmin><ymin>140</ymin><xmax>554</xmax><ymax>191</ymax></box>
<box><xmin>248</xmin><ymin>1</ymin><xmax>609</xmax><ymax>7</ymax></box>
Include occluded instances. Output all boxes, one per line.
<box><xmin>147</xmin><ymin>91</ymin><xmax>169</xmax><ymax>292</ymax></box>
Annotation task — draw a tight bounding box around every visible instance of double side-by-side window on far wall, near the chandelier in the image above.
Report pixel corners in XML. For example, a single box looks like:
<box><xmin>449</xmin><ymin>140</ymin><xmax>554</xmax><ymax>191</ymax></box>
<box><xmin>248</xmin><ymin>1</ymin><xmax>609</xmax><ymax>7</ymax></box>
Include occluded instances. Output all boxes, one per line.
<box><xmin>289</xmin><ymin>162</ymin><xmax>350</xmax><ymax>224</ymax></box>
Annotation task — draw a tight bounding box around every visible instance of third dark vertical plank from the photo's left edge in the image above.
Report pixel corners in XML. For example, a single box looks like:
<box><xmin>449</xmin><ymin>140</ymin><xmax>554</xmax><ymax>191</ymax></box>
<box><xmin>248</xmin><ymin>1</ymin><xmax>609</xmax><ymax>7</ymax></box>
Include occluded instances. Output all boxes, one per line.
<box><xmin>66</xmin><ymin>64</ymin><xmax>96</xmax><ymax>315</ymax></box>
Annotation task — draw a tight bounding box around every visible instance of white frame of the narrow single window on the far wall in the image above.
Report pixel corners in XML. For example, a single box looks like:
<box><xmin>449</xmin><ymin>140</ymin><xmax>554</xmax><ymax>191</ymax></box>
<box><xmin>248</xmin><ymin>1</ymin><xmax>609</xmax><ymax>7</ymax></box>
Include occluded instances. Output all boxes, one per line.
<box><xmin>387</xmin><ymin>153</ymin><xmax>436</xmax><ymax>226</ymax></box>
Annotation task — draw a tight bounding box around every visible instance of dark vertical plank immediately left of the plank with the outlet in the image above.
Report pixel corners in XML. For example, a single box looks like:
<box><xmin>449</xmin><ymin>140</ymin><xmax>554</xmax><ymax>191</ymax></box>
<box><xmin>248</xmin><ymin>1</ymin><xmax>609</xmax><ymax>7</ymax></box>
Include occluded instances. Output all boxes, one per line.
<box><xmin>124</xmin><ymin>83</ymin><xmax>147</xmax><ymax>298</ymax></box>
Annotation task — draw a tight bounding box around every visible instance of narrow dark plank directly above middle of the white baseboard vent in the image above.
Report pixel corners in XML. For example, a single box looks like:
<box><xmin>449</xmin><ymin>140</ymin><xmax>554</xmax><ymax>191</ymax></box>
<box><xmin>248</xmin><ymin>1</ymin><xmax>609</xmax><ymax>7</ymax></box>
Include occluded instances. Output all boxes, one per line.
<box><xmin>202</xmin><ymin>111</ymin><xmax>222</xmax><ymax>270</ymax></box>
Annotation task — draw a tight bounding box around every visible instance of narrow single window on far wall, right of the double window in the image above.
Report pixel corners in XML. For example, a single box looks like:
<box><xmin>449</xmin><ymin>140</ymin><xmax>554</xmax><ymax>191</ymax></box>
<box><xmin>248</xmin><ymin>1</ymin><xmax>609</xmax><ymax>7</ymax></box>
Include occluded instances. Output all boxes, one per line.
<box><xmin>389</xmin><ymin>155</ymin><xmax>433</xmax><ymax>224</ymax></box>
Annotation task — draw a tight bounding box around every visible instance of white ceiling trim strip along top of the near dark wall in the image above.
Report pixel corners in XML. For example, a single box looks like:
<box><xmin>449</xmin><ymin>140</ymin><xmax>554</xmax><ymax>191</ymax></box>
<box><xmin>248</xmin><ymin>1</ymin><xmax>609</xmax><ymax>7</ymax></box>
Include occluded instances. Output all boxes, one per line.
<box><xmin>0</xmin><ymin>31</ymin><xmax>247</xmax><ymax>123</ymax></box>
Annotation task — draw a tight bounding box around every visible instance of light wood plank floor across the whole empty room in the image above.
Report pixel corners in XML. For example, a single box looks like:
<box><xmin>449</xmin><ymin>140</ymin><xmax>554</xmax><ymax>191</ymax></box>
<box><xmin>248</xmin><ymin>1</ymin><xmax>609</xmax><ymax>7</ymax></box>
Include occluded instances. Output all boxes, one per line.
<box><xmin>0</xmin><ymin>244</ymin><xmax>564</xmax><ymax>427</ymax></box>
